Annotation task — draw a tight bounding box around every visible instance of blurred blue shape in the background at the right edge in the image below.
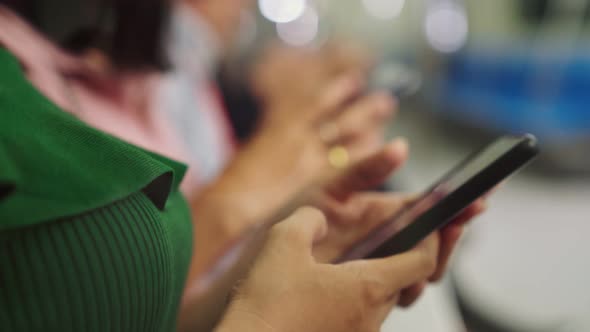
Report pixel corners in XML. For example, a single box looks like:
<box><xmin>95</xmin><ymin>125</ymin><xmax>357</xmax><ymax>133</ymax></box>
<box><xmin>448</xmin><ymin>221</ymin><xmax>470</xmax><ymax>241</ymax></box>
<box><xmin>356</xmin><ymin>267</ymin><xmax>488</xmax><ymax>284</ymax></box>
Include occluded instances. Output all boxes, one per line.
<box><xmin>438</xmin><ymin>50</ymin><xmax>590</xmax><ymax>145</ymax></box>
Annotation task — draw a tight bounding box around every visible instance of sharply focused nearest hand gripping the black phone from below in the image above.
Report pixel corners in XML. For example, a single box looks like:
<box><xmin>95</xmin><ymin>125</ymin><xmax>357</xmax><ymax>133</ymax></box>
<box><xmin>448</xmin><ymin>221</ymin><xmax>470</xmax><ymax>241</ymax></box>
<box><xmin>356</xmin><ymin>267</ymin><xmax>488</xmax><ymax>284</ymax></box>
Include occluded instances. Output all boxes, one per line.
<box><xmin>217</xmin><ymin>208</ymin><xmax>440</xmax><ymax>332</ymax></box>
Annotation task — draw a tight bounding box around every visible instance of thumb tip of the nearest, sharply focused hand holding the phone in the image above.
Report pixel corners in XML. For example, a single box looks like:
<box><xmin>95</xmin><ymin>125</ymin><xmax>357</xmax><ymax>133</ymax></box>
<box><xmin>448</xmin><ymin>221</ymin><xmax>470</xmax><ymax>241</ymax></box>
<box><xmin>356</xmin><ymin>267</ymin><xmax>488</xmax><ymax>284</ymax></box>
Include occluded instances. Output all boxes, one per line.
<box><xmin>271</xmin><ymin>207</ymin><xmax>328</xmax><ymax>257</ymax></box>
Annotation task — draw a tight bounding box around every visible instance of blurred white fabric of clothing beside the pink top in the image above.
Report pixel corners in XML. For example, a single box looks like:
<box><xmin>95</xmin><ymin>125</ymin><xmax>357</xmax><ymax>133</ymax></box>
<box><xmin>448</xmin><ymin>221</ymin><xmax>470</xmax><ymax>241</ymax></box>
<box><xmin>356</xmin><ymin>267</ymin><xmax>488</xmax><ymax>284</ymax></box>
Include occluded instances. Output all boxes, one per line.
<box><xmin>157</xmin><ymin>4</ymin><xmax>233</xmax><ymax>189</ymax></box>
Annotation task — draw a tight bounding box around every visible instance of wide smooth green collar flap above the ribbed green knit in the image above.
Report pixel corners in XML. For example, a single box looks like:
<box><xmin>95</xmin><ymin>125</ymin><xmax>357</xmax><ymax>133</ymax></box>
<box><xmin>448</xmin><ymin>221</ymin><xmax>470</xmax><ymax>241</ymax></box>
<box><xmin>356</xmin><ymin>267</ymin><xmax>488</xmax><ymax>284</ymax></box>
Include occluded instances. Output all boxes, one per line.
<box><xmin>0</xmin><ymin>49</ymin><xmax>185</xmax><ymax>230</ymax></box>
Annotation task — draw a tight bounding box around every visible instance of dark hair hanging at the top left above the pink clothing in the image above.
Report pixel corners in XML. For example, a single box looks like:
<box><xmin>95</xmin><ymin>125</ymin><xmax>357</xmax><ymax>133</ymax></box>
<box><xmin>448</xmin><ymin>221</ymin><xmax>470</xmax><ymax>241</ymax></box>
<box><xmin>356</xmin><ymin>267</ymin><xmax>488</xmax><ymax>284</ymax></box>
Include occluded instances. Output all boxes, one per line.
<box><xmin>0</xmin><ymin>0</ymin><xmax>172</xmax><ymax>70</ymax></box>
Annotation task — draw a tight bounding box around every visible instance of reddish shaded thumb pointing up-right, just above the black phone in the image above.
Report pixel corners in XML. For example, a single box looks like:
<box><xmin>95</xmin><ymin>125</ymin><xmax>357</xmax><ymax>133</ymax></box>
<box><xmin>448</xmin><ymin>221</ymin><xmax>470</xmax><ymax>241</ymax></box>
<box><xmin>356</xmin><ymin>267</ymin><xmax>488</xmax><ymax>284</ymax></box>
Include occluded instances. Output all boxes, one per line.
<box><xmin>327</xmin><ymin>138</ymin><xmax>408</xmax><ymax>200</ymax></box>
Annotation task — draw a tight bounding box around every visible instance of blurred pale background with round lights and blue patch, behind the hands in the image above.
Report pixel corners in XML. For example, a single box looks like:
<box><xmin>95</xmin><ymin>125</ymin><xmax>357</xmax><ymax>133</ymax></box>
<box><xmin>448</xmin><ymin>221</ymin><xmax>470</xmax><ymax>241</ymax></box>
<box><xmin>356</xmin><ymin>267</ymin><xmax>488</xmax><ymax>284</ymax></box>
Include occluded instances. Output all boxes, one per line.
<box><xmin>219</xmin><ymin>0</ymin><xmax>590</xmax><ymax>332</ymax></box>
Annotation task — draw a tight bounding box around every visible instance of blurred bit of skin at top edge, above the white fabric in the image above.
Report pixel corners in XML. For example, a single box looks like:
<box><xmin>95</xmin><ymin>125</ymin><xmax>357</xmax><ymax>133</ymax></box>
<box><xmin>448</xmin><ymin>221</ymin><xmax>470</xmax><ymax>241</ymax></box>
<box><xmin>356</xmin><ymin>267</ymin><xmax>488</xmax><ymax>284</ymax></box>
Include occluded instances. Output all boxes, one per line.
<box><xmin>186</xmin><ymin>0</ymin><xmax>255</xmax><ymax>48</ymax></box>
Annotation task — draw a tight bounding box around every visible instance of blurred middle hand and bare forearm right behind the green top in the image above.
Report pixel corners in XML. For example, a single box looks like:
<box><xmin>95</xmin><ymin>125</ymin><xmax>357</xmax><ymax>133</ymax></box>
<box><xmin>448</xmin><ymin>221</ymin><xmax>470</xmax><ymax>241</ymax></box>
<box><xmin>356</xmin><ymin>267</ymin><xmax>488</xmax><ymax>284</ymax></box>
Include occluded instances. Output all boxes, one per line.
<box><xmin>190</xmin><ymin>76</ymin><xmax>395</xmax><ymax>280</ymax></box>
